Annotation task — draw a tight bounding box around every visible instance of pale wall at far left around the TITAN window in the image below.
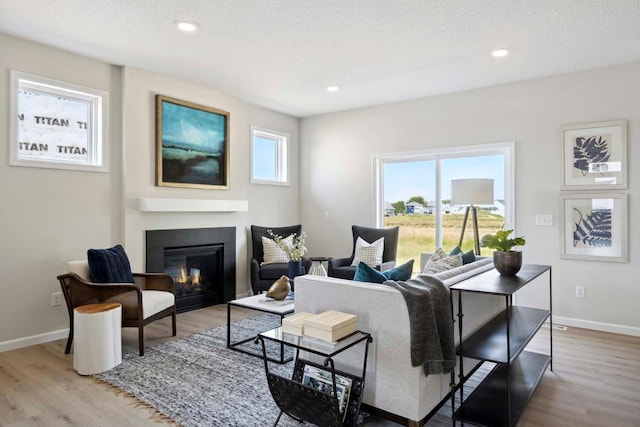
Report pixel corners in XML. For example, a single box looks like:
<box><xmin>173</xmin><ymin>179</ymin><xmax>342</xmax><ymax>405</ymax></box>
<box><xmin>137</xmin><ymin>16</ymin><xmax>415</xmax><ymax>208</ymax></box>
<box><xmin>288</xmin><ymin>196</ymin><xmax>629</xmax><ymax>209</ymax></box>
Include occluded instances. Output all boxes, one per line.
<box><xmin>0</xmin><ymin>34</ymin><xmax>122</xmax><ymax>344</ymax></box>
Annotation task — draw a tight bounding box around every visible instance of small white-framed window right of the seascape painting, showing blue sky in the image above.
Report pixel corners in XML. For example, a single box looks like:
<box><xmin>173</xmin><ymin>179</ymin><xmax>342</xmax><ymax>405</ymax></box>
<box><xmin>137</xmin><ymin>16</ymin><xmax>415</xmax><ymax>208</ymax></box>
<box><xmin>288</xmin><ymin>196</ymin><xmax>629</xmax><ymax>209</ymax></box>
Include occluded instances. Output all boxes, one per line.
<box><xmin>251</xmin><ymin>126</ymin><xmax>289</xmax><ymax>185</ymax></box>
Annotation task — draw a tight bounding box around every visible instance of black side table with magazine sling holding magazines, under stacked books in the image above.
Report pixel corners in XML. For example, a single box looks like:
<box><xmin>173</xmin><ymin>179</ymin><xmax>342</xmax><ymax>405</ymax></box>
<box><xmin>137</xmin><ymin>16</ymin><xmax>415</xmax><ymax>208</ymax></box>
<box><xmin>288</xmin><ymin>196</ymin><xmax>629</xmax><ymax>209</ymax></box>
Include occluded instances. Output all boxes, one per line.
<box><xmin>256</xmin><ymin>327</ymin><xmax>373</xmax><ymax>427</ymax></box>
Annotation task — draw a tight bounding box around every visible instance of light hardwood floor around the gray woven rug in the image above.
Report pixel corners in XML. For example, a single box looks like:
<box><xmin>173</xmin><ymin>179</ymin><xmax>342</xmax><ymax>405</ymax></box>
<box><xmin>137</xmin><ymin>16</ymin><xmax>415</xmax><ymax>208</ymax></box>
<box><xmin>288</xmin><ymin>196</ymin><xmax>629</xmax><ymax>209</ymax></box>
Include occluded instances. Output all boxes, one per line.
<box><xmin>0</xmin><ymin>305</ymin><xmax>640</xmax><ymax>427</ymax></box>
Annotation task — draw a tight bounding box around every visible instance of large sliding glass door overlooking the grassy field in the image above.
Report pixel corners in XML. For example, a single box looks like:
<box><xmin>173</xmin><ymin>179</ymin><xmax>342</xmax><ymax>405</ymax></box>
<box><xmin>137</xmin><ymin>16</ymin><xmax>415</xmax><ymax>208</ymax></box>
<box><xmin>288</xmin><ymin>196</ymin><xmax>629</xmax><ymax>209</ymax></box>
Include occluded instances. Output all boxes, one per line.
<box><xmin>375</xmin><ymin>142</ymin><xmax>515</xmax><ymax>272</ymax></box>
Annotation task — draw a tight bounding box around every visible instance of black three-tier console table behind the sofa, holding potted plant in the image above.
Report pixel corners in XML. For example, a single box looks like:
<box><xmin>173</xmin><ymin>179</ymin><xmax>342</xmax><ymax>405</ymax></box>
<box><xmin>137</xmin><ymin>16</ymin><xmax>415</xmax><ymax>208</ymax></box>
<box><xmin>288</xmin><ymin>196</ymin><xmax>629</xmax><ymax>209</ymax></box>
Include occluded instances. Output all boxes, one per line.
<box><xmin>450</xmin><ymin>264</ymin><xmax>553</xmax><ymax>427</ymax></box>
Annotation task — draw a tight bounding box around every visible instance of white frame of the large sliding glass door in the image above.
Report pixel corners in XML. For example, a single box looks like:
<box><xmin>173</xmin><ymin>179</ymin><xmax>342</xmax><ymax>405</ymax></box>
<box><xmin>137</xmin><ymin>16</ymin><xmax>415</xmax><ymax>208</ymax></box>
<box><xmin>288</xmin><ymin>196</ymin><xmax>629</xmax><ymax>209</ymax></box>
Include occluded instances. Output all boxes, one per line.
<box><xmin>373</xmin><ymin>141</ymin><xmax>516</xmax><ymax>247</ymax></box>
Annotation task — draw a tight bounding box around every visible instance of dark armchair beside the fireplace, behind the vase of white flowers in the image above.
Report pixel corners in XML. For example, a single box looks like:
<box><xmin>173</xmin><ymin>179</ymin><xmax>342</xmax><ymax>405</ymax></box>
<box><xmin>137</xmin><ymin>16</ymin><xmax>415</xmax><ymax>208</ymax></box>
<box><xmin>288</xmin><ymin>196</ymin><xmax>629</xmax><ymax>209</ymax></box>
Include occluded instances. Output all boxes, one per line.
<box><xmin>251</xmin><ymin>225</ymin><xmax>311</xmax><ymax>295</ymax></box>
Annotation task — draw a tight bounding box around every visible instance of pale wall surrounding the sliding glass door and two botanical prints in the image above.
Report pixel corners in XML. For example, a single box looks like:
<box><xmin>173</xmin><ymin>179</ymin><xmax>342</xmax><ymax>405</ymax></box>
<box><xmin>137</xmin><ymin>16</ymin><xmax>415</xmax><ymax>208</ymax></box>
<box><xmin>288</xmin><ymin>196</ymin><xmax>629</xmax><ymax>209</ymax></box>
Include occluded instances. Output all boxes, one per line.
<box><xmin>300</xmin><ymin>62</ymin><xmax>640</xmax><ymax>334</ymax></box>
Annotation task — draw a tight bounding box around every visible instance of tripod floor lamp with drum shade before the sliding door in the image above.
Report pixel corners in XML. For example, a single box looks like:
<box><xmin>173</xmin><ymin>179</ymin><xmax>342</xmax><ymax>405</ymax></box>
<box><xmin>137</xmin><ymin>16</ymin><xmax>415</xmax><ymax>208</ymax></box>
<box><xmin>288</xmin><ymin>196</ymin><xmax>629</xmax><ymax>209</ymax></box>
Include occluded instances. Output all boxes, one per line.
<box><xmin>451</xmin><ymin>178</ymin><xmax>494</xmax><ymax>255</ymax></box>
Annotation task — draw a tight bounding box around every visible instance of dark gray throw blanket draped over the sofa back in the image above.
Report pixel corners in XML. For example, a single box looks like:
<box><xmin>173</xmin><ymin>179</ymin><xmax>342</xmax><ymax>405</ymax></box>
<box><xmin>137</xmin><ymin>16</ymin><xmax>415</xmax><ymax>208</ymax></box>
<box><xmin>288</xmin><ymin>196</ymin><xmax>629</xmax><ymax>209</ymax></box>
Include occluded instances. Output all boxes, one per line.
<box><xmin>384</xmin><ymin>275</ymin><xmax>456</xmax><ymax>375</ymax></box>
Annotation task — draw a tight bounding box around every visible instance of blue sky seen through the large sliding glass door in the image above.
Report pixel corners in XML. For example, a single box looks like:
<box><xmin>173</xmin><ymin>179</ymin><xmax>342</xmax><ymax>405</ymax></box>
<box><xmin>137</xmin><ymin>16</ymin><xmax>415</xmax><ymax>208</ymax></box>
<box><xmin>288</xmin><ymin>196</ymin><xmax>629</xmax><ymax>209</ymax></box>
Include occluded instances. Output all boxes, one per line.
<box><xmin>384</xmin><ymin>155</ymin><xmax>505</xmax><ymax>203</ymax></box>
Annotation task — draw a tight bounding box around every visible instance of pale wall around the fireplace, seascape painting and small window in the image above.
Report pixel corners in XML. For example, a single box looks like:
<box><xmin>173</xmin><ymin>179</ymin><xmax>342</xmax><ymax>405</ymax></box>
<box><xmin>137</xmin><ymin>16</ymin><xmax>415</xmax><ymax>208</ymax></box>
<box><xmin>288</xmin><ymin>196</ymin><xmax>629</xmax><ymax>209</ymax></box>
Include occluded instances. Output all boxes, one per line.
<box><xmin>123</xmin><ymin>67</ymin><xmax>300</xmax><ymax>295</ymax></box>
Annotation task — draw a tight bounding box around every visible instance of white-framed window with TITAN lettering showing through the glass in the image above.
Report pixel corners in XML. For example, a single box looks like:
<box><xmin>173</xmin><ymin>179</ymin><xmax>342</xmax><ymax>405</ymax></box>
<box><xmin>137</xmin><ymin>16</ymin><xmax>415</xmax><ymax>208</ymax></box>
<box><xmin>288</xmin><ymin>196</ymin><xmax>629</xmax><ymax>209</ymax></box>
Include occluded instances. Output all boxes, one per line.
<box><xmin>9</xmin><ymin>70</ymin><xmax>108</xmax><ymax>172</ymax></box>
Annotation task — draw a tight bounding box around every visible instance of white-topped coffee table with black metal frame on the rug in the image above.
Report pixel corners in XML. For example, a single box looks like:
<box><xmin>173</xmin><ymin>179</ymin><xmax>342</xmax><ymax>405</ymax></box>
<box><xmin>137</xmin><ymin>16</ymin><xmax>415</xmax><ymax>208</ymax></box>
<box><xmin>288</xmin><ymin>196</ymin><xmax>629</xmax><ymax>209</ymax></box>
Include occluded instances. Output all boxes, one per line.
<box><xmin>227</xmin><ymin>294</ymin><xmax>294</xmax><ymax>364</ymax></box>
